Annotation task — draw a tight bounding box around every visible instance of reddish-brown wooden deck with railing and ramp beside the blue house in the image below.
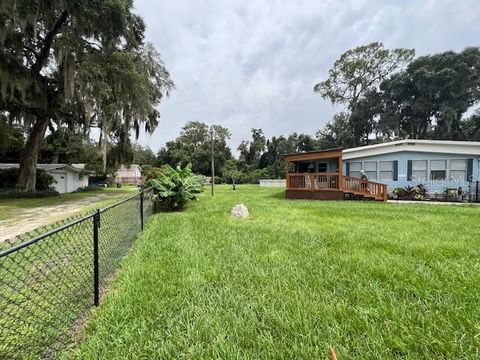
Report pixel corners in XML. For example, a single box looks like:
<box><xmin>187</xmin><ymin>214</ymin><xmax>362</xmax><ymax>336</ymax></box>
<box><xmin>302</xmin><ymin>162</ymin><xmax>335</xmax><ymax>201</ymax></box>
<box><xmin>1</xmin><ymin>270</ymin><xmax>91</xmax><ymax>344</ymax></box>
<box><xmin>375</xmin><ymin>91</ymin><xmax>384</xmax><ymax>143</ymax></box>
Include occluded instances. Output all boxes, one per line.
<box><xmin>286</xmin><ymin>172</ymin><xmax>387</xmax><ymax>201</ymax></box>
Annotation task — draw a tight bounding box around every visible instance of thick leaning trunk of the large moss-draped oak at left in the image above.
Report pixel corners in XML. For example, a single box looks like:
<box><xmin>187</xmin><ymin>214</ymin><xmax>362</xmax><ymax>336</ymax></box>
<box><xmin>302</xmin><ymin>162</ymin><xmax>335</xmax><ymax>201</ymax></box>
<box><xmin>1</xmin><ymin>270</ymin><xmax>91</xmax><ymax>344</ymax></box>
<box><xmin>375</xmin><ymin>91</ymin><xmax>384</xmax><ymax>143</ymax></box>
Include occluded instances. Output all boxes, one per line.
<box><xmin>17</xmin><ymin>114</ymin><xmax>49</xmax><ymax>192</ymax></box>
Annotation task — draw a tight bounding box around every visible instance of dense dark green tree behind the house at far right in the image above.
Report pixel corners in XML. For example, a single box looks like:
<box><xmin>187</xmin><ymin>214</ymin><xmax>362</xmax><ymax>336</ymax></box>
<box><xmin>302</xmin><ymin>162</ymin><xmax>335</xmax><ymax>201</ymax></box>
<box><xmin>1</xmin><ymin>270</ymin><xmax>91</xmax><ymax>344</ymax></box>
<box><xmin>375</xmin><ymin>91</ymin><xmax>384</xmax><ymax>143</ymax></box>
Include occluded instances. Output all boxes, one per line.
<box><xmin>379</xmin><ymin>48</ymin><xmax>480</xmax><ymax>140</ymax></box>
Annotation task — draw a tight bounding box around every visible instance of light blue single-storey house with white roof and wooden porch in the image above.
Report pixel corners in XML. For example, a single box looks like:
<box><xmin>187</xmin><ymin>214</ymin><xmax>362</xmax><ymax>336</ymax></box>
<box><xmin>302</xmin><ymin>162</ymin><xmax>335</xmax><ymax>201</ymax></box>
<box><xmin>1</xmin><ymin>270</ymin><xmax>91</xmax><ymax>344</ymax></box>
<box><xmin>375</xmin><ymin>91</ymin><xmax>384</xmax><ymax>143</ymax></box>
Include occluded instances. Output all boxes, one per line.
<box><xmin>284</xmin><ymin>139</ymin><xmax>480</xmax><ymax>200</ymax></box>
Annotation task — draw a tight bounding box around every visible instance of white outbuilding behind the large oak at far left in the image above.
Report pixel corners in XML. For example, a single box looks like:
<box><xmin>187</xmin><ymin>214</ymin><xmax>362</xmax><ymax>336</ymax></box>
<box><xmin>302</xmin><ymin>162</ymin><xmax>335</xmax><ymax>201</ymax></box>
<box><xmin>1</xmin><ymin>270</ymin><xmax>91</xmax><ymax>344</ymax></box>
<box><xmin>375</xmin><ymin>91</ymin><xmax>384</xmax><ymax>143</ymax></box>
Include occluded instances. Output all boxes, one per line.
<box><xmin>0</xmin><ymin>164</ymin><xmax>88</xmax><ymax>194</ymax></box>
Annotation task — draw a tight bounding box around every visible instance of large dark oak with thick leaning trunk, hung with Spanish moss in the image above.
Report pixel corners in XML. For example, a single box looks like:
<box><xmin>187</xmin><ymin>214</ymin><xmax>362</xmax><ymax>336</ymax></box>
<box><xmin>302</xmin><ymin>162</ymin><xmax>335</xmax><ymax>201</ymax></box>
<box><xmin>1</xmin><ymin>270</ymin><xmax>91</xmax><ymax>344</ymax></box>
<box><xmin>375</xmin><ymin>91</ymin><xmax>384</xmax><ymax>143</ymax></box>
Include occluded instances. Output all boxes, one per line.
<box><xmin>0</xmin><ymin>0</ymin><xmax>172</xmax><ymax>191</ymax></box>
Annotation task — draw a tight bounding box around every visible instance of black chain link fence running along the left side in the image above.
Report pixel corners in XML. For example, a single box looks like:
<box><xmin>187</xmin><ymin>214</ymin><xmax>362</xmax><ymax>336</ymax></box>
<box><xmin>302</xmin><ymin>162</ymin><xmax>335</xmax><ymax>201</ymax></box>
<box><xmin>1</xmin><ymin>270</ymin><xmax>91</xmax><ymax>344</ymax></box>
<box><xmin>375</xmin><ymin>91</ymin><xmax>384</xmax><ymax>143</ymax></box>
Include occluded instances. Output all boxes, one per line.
<box><xmin>0</xmin><ymin>189</ymin><xmax>153</xmax><ymax>359</ymax></box>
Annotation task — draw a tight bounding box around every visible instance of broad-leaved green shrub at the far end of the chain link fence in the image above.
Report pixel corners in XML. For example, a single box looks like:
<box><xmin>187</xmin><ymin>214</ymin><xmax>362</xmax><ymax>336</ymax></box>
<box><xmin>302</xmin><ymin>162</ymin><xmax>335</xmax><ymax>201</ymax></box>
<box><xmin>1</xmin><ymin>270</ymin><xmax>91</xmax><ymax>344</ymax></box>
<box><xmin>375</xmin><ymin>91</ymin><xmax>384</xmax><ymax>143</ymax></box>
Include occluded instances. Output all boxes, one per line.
<box><xmin>148</xmin><ymin>164</ymin><xmax>205</xmax><ymax>211</ymax></box>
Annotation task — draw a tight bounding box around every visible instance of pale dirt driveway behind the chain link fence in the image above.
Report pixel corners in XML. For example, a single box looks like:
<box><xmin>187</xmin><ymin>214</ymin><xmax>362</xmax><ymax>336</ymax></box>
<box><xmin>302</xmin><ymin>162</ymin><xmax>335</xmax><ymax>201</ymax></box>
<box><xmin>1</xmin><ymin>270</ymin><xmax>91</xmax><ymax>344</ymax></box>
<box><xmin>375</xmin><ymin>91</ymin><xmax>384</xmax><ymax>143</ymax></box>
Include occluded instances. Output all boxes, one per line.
<box><xmin>0</xmin><ymin>194</ymin><xmax>111</xmax><ymax>241</ymax></box>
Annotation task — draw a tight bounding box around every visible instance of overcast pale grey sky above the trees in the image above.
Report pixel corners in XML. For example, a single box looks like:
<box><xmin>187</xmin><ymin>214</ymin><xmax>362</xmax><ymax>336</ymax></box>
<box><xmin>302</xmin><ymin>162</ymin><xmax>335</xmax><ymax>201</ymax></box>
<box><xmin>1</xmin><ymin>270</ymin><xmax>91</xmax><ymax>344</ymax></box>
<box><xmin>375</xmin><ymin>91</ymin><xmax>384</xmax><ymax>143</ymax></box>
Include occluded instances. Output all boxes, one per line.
<box><xmin>135</xmin><ymin>0</ymin><xmax>480</xmax><ymax>151</ymax></box>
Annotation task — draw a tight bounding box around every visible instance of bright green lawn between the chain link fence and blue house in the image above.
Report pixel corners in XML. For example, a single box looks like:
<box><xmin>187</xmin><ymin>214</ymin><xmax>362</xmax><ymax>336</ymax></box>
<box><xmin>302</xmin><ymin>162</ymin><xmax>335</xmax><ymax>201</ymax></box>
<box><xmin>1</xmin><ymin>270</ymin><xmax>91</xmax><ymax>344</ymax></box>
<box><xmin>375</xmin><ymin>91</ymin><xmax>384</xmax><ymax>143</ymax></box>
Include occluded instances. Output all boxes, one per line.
<box><xmin>64</xmin><ymin>186</ymin><xmax>480</xmax><ymax>359</ymax></box>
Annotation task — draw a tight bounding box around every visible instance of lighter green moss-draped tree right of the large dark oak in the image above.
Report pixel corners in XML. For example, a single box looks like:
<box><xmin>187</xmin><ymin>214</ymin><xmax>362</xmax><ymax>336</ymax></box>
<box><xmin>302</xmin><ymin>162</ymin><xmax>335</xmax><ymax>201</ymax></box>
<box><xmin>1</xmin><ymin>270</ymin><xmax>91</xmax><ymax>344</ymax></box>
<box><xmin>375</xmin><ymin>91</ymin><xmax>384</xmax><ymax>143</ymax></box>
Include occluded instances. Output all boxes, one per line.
<box><xmin>79</xmin><ymin>44</ymin><xmax>173</xmax><ymax>171</ymax></box>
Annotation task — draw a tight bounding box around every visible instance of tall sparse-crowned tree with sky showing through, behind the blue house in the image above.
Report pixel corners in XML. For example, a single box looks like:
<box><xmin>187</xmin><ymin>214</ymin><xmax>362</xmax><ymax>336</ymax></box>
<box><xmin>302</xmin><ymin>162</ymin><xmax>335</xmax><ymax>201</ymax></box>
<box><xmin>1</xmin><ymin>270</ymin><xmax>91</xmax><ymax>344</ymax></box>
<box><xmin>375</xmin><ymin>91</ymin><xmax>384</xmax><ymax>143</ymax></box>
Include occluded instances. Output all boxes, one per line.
<box><xmin>314</xmin><ymin>42</ymin><xmax>415</xmax><ymax>146</ymax></box>
